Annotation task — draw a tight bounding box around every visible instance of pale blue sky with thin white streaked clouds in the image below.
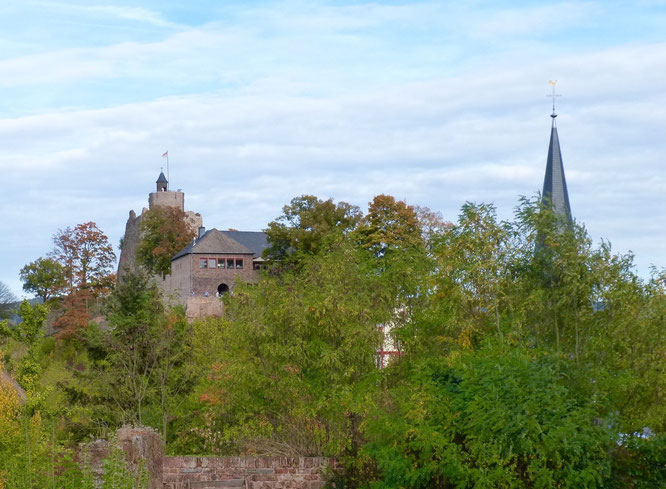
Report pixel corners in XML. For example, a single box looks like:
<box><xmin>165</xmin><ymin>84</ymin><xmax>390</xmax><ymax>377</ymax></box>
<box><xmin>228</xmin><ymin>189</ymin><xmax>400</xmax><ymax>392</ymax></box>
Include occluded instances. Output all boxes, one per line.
<box><xmin>0</xmin><ymin>0</ymin><xmax>666</xmax><ymax>297</ymax></box>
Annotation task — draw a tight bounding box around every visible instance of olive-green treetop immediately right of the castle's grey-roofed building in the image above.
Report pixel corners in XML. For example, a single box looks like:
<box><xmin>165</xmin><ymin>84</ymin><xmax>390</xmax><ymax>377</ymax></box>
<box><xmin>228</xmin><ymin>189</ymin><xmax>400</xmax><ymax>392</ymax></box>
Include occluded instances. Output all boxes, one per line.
<box><xmin>264</xmin><ymin>195</ymin><xmax>361</xmax><ymax>261</ymax></box>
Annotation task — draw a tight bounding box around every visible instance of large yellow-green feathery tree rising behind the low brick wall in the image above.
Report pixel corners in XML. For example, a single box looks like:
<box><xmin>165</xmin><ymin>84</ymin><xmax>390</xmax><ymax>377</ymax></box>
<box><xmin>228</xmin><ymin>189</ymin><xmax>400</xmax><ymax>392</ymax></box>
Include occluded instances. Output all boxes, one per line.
<box><xmin>187</xmin><ymin>240</ymin><xmax>386</xmax><ymax>456</ymax></box>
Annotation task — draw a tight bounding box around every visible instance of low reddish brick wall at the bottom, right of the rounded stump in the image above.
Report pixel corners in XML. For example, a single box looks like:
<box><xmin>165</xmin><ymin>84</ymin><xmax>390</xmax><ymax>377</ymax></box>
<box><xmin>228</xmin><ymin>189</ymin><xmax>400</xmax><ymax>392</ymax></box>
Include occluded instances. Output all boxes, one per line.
<box><xmin>162</xmin><ymin>457</ymin><xmax>335</xmax><ymax>489</ymax></box>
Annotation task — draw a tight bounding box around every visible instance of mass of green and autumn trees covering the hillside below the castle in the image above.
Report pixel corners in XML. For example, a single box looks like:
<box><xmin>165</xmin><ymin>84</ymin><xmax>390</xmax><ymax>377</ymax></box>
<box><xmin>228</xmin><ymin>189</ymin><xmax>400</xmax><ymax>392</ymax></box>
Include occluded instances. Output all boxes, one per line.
<box><xmin>0</xmin><ymin>195</ymin><xmax>666</xmax><ymax>489</ymax></box>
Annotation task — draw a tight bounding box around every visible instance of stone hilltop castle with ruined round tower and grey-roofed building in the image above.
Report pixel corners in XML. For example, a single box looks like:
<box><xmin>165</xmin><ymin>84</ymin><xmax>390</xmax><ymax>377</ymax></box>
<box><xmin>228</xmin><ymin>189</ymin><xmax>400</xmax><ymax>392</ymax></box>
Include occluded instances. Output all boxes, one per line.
<box><xmin>118</xmin><ymin>172</ymin><xmax>268</xmax><ymax>318</ymax></box>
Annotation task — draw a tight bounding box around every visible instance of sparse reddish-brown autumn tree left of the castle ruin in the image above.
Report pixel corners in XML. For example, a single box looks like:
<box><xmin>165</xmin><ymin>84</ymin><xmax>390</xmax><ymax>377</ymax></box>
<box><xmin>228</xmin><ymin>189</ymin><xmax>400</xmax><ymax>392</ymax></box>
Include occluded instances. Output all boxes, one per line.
<box><xmin>49</xmin><ymin>222</ymin><xmax>116</xmax><ymax>292</ymax></box>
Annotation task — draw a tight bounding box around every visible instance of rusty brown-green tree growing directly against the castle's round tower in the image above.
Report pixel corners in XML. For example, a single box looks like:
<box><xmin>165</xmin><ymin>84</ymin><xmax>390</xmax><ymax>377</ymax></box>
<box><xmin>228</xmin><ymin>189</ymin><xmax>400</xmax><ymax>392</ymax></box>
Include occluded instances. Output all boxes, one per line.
<box><xmin>136</xmin><ymin>207</ymin><xmax>196</xmax><ymax>275</ymax></box>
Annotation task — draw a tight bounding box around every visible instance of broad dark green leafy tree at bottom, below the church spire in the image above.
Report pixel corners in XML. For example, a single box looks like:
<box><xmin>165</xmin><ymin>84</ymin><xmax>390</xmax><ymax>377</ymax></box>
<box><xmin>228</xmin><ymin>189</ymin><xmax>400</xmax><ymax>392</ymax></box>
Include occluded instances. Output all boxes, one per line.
<box><xmin>366</xmin><ymin>344</ymin><xmax>613</xmax><ymax>489</ymax></box>
